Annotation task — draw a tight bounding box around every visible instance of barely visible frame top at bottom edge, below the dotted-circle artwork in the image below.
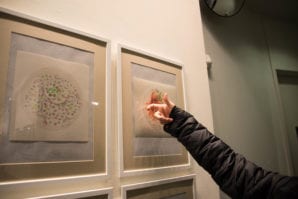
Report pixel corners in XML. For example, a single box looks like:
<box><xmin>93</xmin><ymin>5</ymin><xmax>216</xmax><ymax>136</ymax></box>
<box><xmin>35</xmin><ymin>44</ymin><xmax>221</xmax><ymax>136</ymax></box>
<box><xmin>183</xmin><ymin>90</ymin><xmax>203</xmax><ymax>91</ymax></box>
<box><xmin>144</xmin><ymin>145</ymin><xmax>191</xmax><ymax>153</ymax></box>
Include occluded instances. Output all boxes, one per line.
<box><xmin>34</xmin><ymin>188</ymin><xmax>113</xmax><ymax>199</ymax></box>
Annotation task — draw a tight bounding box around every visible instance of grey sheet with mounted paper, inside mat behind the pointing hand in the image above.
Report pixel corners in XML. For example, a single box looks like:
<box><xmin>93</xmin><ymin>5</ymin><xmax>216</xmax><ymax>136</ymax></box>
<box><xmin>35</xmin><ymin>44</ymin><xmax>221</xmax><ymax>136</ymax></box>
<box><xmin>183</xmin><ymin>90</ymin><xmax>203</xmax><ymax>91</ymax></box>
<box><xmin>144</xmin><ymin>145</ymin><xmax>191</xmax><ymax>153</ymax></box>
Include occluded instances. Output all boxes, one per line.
<box><xmin>132</xmin><ymin>64</ymin><xmax>182</xmax><ymax>156</ymax></box>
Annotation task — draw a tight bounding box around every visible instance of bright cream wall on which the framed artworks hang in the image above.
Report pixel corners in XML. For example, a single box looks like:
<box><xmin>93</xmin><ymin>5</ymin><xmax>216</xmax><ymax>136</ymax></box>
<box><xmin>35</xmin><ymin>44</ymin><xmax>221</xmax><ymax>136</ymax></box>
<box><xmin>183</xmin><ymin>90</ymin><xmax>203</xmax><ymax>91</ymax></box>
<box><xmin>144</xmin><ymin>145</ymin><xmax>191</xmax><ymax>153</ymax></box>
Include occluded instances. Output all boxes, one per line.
<box><xmin>0</xmin><ymin>0</ymin><xmax>219</xmax><ymax>199</ymax></box>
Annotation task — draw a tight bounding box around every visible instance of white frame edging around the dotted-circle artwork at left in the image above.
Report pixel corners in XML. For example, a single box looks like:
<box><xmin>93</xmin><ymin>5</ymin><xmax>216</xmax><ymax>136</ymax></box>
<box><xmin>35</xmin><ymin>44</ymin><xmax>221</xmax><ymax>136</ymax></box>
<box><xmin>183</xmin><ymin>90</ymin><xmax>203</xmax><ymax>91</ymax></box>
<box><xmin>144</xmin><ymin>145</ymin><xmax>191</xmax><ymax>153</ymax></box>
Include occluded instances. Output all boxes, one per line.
<box><xmin>0</xmin><ymin>7</ymin><xmax>111</xmax><ymax>190</ymax></box>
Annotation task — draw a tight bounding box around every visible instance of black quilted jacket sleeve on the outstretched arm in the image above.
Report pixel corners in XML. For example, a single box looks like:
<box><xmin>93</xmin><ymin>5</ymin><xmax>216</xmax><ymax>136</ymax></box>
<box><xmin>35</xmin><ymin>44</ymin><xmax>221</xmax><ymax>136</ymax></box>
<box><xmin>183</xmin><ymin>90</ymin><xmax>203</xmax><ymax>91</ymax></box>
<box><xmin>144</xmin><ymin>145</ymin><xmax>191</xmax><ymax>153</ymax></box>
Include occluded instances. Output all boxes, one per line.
<box><xmin>164</xmin><ymin>107</ymin><xmax>298</xmax><ymax>199</ymax></box>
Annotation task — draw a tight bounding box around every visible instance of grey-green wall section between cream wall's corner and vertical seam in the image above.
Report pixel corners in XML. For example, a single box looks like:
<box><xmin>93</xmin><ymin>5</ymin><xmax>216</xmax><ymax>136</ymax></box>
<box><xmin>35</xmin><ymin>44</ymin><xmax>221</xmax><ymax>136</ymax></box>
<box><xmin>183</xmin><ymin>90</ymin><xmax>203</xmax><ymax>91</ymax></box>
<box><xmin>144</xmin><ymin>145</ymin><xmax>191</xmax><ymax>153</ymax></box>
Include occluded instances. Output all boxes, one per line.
<box><xmin>200</xmin><ymin>1</ymin><xmax>290</xmax><ymax>171</ymax></box>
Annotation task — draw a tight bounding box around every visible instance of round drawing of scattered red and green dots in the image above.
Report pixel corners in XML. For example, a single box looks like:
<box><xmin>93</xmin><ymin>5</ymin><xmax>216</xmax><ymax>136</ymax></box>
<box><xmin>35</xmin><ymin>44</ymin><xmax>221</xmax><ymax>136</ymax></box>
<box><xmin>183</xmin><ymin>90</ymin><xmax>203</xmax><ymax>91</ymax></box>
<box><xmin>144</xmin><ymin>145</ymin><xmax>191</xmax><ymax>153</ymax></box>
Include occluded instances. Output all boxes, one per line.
<box><xmin>23</xmin><ymin>69</ymin><xmax>82</xmax><ymax>130</ymax></box>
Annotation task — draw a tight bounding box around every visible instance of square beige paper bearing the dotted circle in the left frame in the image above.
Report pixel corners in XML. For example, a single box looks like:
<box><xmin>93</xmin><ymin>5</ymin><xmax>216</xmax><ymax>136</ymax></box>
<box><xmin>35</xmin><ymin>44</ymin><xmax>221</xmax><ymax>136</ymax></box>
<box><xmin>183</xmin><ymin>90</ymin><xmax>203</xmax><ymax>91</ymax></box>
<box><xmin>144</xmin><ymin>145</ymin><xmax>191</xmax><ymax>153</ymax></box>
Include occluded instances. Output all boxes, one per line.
<box><xmin>9</xmin><ymin>51</ymin><xmax>89</xmax><ymax>142</ymax></box>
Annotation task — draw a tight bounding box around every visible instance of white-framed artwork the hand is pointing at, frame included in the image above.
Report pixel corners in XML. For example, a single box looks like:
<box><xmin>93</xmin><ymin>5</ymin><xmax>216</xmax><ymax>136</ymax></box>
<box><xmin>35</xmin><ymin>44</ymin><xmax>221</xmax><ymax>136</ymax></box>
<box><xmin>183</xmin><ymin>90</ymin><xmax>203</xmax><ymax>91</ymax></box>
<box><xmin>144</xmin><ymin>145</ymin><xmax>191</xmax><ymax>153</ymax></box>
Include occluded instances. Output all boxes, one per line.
<box><xmin>118</xmin><ymin>46</ymin><xmax>189</xmax><ymax>175</ymax></box>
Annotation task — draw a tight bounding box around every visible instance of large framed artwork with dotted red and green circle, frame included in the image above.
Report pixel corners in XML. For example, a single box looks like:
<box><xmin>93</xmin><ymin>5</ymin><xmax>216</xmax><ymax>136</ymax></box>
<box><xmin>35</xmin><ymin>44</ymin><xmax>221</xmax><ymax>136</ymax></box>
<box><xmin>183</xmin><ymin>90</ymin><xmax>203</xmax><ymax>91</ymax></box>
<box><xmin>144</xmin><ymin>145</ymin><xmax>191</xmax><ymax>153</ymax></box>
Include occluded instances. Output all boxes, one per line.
<box><xmin>0</xmin><ymin>9</ymin><xmax>110</xmax><ymax>183</ymax></box>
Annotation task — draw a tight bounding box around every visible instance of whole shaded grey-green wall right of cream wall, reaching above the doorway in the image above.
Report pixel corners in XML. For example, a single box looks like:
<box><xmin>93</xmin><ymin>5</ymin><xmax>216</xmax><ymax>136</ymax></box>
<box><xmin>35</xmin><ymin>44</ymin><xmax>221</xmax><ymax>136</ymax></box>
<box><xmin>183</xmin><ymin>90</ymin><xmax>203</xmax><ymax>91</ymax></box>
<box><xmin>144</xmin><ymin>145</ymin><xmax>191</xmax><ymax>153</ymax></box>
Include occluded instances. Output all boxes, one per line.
<box><xmin>201</xmin><ymin>0</ymin><xmax>298</xmax><ymax>180</ymax></box>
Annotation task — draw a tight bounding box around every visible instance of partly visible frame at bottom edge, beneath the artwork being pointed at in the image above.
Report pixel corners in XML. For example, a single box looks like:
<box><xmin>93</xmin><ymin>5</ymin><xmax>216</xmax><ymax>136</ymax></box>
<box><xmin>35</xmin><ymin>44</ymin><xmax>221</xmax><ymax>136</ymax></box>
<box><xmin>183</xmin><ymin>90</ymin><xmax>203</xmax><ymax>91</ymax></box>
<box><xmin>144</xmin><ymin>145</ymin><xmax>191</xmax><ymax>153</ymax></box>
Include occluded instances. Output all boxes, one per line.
<box><xmin>121</xmin><ymin>175</ymin><xmax>196</xmax><ymax>199</ymax></box>
